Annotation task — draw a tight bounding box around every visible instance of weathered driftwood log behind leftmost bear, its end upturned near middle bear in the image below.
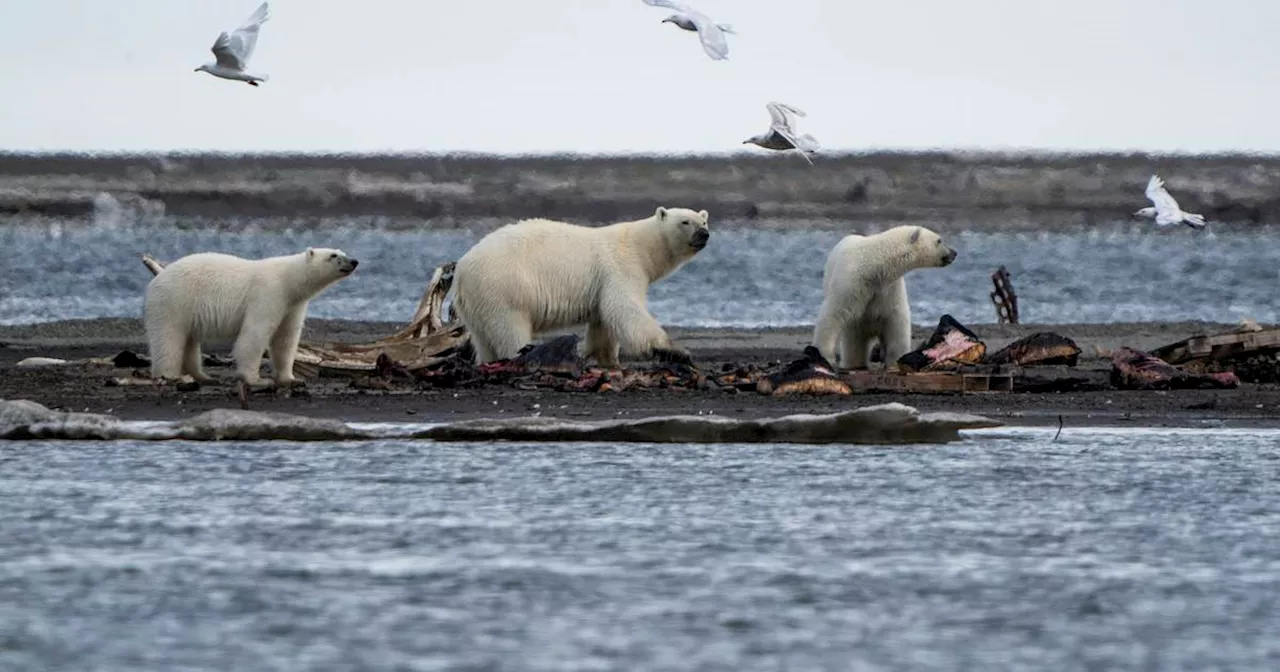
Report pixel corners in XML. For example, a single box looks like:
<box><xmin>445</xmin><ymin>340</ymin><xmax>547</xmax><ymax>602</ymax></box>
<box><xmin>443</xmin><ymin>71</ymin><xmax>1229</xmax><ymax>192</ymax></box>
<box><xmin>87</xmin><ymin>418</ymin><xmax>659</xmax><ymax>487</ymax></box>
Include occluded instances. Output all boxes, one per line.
<box><xmin>142</xmin><ymin>255</ymin><xmax>471</xmax><ymax>378</ymax></box>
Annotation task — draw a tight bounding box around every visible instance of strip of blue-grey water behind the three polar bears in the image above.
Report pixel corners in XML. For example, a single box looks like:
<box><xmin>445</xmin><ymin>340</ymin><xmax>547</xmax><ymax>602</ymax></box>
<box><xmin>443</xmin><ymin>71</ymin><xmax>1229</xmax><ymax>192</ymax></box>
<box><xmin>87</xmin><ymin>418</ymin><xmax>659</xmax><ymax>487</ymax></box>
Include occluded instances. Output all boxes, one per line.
<box><xmin>0</xmin><ymin>215</ymin><xmax>1280</xmax><ymax>326</ymax></box>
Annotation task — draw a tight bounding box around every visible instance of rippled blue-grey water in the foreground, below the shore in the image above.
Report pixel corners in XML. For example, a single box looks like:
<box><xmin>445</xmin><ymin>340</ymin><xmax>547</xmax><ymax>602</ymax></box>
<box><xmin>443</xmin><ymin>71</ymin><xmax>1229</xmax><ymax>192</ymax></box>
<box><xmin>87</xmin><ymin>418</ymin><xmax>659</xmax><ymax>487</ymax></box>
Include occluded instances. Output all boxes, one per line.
<box><xmin>0</xmin><ymin>428</ymin><xmax>1280</xmax><ymax>672</ymax></box>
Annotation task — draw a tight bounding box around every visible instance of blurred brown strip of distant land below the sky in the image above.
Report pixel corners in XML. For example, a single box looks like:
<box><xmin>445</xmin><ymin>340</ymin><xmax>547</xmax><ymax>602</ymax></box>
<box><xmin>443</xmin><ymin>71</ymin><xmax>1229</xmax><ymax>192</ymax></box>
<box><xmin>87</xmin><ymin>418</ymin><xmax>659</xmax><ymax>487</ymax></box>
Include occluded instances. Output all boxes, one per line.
<box><xmin>0</xmin><ymin>152</ymin><xmax>1280</xmax><ymax>230</ymax></box>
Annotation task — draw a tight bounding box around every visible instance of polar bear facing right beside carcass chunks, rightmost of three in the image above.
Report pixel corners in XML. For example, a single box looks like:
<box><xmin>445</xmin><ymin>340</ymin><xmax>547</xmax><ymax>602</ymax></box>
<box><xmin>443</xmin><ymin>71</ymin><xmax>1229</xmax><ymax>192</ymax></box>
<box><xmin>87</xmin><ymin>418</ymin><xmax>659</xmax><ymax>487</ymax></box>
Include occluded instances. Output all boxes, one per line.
<box><xmin>813</xmin><ymin>227</ymin><xmax>956</xmax><ymax>369</ymax></box>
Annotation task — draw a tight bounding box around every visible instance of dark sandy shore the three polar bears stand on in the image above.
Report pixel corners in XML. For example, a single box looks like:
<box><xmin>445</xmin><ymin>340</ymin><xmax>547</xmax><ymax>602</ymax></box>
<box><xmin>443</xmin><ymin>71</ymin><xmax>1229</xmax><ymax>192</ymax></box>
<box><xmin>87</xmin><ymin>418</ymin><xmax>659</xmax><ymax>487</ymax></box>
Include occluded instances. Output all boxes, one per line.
<box><xmin>0</xmin><ymin>319</ymin><xmax>1280</xmax><ymax>428</ymax></box>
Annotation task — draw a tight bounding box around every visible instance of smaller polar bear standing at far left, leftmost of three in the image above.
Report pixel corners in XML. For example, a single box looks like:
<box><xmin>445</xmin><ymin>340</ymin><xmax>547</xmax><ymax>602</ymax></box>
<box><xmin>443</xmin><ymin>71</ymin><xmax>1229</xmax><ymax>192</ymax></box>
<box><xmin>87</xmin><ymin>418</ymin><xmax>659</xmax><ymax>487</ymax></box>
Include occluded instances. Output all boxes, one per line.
<box><xmin>142</xmin><ymin>247</ymin><xmax>360</xmax><ymax>387</ymax></box>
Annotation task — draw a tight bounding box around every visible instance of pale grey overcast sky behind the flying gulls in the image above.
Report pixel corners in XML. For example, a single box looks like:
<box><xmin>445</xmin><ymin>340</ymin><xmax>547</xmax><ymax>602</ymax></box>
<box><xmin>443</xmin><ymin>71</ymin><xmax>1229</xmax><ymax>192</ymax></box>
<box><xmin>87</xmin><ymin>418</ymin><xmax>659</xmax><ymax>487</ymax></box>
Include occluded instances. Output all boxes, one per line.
<box><xmin>0</xmin><ymin>0</ymin><xmax>1280</xmax><ymax>152</ymax></box>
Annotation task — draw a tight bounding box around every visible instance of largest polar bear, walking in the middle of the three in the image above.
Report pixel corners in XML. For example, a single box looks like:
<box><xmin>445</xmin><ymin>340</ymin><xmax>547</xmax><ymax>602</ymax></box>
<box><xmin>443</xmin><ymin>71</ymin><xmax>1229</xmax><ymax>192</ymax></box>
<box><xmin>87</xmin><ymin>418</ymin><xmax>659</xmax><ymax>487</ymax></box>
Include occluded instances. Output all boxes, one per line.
<box><xmin>453</xmin><ymin>207</ymin><xmax>710</xmax><ymax>367</ymax></box>
